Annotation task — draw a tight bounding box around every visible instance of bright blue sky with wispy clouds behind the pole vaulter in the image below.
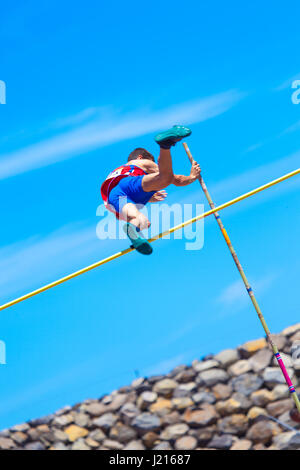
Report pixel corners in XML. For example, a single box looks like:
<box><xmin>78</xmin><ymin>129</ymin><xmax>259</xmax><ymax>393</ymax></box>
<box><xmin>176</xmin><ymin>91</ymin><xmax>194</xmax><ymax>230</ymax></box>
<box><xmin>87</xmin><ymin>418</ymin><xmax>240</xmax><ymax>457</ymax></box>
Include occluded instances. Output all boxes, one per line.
<box><xmin>0</xmin><ymin>0</ymin><xmax>300</xmax><ymax>428</ymax></box>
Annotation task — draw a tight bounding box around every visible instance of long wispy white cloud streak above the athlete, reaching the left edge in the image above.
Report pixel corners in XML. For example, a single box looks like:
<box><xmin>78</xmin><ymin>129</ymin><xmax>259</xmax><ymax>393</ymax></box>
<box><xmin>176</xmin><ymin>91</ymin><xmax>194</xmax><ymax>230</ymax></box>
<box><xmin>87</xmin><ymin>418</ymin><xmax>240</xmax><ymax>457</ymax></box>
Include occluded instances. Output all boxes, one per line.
<box><xmin>0</xmin><ymin>90</ymin><xmax>245</xmax><ymax>179</ymax></box>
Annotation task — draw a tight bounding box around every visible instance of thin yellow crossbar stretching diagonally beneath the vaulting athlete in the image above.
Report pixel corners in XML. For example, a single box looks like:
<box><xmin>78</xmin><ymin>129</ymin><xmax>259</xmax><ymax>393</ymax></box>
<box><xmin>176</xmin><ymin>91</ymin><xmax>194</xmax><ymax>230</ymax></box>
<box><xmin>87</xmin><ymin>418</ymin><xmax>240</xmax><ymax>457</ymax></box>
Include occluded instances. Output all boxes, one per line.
<box><xmin>0</xmin><ymin>168</ymin><xmax>300</xmax><ymax>311</ymax></box>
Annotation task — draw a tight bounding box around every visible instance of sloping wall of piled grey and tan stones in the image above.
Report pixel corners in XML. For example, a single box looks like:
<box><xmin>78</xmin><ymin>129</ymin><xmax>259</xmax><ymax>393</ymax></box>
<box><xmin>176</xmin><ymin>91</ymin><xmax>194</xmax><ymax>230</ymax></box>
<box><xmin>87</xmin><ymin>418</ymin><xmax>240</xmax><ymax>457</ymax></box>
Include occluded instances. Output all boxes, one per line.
<box><xmin>0</xmin><ymin>323</ymin><xmax>300</xmax><ymax>450</ymax></box>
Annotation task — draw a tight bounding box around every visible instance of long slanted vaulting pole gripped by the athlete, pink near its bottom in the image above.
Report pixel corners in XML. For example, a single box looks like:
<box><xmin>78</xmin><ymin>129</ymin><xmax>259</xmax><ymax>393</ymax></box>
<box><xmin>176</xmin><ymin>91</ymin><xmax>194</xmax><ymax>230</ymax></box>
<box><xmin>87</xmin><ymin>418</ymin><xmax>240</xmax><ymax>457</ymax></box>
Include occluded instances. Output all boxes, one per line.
<box><xmin>183</xmin><ymin>142</ymin><xmax>300</xmax><ymax>414</ymax></box>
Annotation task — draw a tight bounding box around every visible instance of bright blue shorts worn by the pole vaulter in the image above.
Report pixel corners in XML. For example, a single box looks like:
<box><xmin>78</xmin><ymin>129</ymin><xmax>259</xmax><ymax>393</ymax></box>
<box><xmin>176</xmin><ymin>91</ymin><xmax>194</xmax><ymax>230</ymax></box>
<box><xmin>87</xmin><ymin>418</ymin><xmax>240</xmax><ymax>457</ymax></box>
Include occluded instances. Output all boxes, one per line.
<box><xmin>107</xmin><ymin>175</ymin><xmax>156</xmax><ymax>213</ymax></box>
